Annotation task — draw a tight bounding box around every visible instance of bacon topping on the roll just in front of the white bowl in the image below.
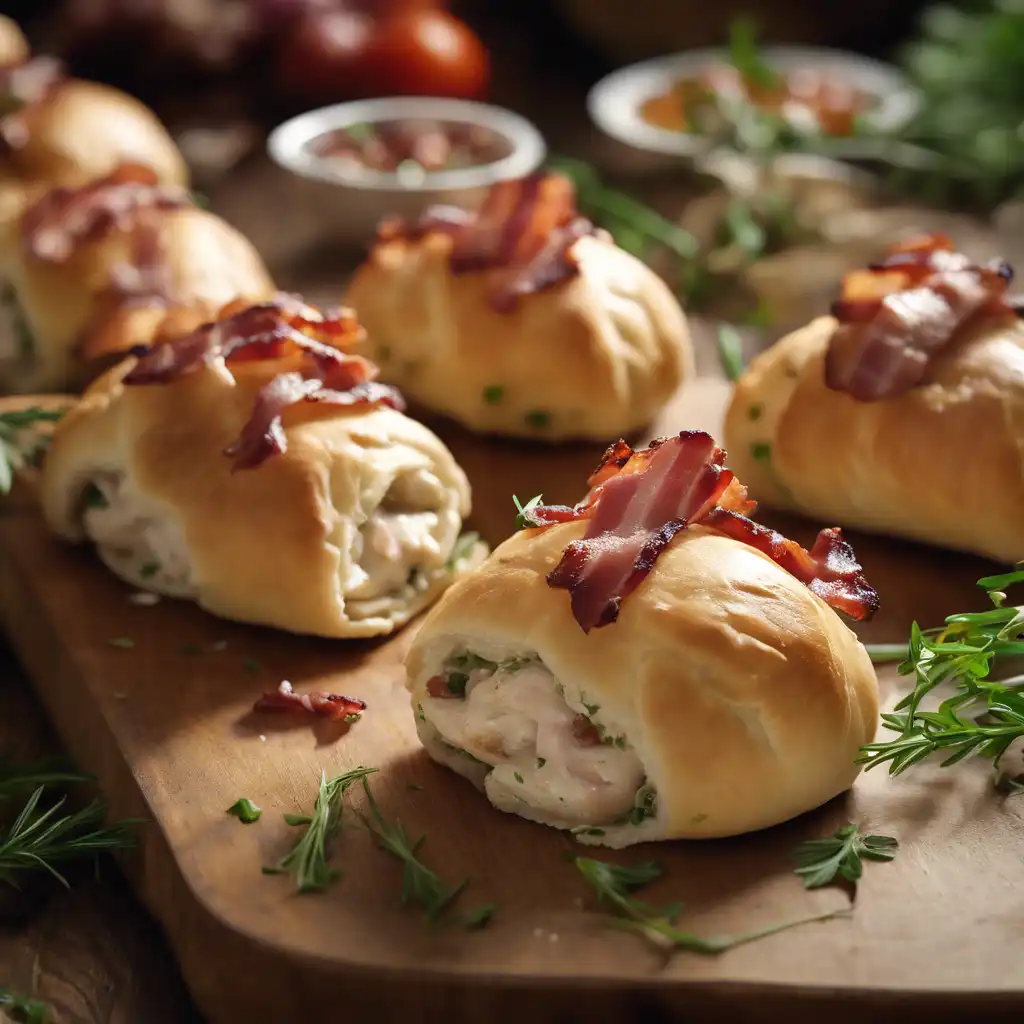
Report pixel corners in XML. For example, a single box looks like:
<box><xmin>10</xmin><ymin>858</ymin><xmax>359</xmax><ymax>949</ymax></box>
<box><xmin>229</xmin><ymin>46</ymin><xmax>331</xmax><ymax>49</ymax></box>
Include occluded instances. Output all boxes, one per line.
<box><xmin>377</xmin><ymin>172</ymin><xmax>598</xmax><ymax>313</ymax></box>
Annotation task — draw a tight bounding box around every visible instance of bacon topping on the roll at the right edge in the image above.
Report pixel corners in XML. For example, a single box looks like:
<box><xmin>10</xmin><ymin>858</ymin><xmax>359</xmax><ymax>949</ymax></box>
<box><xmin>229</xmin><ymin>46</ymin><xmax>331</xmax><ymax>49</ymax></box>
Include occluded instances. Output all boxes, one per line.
<box><xmin>825</xmin><ymin>236</ymin><xmax>1013</xmax><ymax>401</ymax></box>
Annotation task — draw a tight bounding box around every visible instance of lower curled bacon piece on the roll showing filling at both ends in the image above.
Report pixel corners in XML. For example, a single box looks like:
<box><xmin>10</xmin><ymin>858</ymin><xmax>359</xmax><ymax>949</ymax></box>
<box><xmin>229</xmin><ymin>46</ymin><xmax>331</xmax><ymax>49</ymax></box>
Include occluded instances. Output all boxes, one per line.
<box><xmin>224</xmin><ymin>376</ymin><xmax>406</xmax><ymax>470</ymax></box>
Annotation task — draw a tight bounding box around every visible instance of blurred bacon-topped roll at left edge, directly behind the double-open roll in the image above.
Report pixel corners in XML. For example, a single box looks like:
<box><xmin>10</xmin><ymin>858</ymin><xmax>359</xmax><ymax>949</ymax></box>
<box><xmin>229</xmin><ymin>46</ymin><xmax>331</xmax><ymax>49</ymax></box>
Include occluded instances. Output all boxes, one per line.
<box><xmin>0</xmin><ymin>165</ymin><xmax>274</xmax><ymax>392</ymax></box>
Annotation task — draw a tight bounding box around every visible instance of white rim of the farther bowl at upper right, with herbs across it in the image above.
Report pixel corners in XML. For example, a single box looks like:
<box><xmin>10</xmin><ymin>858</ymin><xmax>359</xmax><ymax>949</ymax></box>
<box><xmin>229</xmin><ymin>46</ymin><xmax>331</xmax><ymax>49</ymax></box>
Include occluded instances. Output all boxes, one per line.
<box><xmin>587</xmin><ymin>46</ymin><xmax>921</xmax><ymax>170</ymax></box>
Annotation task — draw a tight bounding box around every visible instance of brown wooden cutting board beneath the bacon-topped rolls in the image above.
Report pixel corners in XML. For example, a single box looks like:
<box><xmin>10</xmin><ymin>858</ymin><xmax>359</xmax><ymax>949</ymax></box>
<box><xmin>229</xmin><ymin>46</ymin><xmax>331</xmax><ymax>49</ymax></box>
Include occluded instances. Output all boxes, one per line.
<box><xmin>0</xmin><ymin>380</ymin><xmax>1024</xmax><ymax>1024</ymax></box>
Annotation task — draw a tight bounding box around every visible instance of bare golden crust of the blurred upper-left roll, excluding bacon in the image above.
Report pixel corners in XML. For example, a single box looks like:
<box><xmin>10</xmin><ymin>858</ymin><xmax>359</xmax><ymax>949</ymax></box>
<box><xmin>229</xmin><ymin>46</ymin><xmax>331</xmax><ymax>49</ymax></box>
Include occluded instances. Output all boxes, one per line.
<box><xmin>0</xmin><ymin>79</ymin><xmax>188</xmax><ymax>187</ymax></box>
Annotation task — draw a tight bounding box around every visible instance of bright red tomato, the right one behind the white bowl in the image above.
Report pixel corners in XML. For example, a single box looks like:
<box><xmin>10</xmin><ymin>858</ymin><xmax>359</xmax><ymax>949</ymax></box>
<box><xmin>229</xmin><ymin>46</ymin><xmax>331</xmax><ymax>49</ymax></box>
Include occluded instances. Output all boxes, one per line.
<box><xmin>365</xmin><ymin>10</ymin><xmax>490</xmax><ymax>99</ymax></box>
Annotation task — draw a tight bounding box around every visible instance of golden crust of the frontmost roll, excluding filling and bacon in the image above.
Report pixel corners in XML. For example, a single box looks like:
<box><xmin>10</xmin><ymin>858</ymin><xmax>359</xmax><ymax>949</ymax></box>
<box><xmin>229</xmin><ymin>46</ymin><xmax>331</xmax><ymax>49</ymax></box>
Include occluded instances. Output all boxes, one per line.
<box><xmin>407</xmin><ymin>522</ymin><xmax>878</xmax><ymax>846</ymax></box>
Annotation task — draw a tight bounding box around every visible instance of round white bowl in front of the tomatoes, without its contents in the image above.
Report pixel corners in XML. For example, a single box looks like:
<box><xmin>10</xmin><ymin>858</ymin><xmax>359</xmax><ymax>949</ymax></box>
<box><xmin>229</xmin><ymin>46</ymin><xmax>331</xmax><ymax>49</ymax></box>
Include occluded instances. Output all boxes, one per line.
<box><xmin>267</xmin><ymin>96</ymin><xmax>547</xmax><ymax>246</ymax></box>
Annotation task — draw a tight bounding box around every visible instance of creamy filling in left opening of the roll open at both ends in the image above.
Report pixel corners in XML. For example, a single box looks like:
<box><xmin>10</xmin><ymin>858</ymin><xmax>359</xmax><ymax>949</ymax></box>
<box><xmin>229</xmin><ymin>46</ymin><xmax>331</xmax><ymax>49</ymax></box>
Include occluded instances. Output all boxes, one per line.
<box><xmin>82</xmin><ymin>473</ymin><xmax>195</xmax><ymax>597</ymax></box>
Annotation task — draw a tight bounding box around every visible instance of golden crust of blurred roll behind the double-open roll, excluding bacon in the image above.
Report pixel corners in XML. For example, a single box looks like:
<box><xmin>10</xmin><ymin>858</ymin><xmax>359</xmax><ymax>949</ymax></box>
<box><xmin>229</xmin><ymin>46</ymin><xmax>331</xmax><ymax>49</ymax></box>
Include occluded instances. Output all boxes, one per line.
<box><xmin>0</xmin><ymin>206</ymin><xmax>274</xmax><ymax>391</ymax></box>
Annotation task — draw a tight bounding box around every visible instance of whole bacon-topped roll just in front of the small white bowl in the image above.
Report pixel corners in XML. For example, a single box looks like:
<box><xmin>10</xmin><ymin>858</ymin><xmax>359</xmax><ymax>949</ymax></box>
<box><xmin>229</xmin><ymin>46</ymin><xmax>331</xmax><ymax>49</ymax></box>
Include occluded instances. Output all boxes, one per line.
<box><xmin>346</xmin><ymin>175</ymin><xmax>692</xmax><ymax>441</ymax></box>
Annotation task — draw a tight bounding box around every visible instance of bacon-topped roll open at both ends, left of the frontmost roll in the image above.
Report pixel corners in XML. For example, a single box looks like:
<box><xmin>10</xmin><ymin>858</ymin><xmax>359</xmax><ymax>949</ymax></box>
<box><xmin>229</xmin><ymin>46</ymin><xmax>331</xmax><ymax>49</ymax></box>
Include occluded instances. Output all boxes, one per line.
<box><xmin>40</xmin><ymin>297</ymin><xmax>479</xmax><ymax>637</ymax></box>
